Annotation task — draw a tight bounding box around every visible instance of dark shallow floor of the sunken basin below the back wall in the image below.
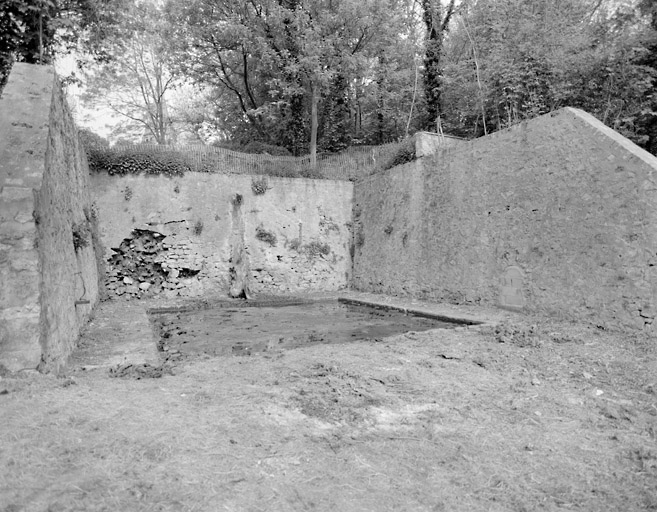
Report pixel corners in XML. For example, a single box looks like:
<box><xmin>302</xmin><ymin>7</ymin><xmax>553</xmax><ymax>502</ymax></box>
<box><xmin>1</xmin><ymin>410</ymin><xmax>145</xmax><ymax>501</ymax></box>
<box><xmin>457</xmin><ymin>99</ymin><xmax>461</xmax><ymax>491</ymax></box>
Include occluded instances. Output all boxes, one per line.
<box><xmin>151</xmin><ymin>301</ymin><xmax>460</xmax><ymax>355</ymax></box>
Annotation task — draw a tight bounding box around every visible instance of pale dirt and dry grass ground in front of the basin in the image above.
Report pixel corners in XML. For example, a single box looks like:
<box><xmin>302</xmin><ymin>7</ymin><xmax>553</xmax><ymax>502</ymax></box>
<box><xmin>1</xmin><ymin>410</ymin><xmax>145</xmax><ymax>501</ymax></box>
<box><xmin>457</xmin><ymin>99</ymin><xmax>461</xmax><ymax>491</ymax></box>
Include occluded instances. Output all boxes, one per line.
<box><xmin>0</xmin><ymin>296</ymin><xmax>657</xmax><ymax>512</ymax></box>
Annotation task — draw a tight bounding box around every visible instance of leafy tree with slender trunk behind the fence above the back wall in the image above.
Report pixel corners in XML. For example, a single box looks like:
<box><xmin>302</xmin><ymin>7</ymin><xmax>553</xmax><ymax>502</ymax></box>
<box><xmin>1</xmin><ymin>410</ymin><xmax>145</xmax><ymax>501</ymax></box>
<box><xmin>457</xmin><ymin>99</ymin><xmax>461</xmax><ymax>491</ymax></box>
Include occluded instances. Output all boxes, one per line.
<box><xmin>168</xmin><ymin>0</ymin><xmax>413</xmax><ymax>154</ymax></box>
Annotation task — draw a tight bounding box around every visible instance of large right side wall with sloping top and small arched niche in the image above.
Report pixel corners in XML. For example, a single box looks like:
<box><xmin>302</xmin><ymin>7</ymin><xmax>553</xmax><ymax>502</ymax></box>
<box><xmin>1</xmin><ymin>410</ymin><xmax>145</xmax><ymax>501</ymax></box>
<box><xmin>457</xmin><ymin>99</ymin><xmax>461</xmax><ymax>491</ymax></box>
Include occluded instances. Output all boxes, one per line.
<box><xmin>353</xmin><ymin>109</ymin><xmax>657</xmax><ymax>329</ymax></box>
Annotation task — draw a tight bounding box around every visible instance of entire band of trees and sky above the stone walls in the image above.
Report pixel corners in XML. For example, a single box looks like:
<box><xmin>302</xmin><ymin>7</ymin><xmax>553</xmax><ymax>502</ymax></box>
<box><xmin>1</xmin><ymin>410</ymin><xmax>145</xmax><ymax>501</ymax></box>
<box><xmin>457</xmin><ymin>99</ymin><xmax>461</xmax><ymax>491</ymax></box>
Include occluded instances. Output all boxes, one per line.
<box><xmin>0</xmin><ymin>0</ymin><xmax>657</xmax><ymax>155</ymax></box>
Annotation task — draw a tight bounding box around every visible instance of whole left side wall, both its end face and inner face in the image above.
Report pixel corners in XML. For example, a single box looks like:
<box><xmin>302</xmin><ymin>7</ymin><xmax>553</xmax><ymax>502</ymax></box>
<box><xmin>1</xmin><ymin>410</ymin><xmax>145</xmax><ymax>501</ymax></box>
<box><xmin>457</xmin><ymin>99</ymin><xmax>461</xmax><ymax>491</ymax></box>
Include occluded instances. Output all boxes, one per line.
<box><xmin>0</xmin><ymin>64</ymin><xmax>98</xmax><ymax>371</ymax></box>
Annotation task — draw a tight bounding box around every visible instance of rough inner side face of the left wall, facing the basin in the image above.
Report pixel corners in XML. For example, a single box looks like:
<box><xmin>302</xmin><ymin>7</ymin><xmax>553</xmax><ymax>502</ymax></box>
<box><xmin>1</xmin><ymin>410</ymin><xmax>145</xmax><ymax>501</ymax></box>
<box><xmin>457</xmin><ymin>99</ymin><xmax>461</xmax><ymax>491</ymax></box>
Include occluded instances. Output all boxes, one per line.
<box><xmin>34</xmin><ymin>72</ymin><xmax>98</xmax><ymax>371</ymax></box>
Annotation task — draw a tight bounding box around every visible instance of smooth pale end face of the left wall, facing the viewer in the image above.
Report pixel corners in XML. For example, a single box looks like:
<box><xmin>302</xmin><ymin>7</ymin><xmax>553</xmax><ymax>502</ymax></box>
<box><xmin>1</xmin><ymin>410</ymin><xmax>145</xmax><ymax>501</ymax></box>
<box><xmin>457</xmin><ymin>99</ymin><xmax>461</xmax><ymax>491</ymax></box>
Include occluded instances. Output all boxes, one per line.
<box><xmin>0</xmin><ymin>64</ymin><xmax>54</xmax><ymax>369</ymax></box>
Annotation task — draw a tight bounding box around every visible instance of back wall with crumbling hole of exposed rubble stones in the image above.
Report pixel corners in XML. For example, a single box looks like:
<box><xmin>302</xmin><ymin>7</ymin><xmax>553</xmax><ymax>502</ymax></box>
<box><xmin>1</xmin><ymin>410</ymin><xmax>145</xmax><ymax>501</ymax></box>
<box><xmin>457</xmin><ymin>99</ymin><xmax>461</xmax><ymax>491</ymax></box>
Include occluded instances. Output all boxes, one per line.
<box><xmin>92</xmin><ymin>172</ymin><xmax>353</xmax><ymax>298</ymax></box>
